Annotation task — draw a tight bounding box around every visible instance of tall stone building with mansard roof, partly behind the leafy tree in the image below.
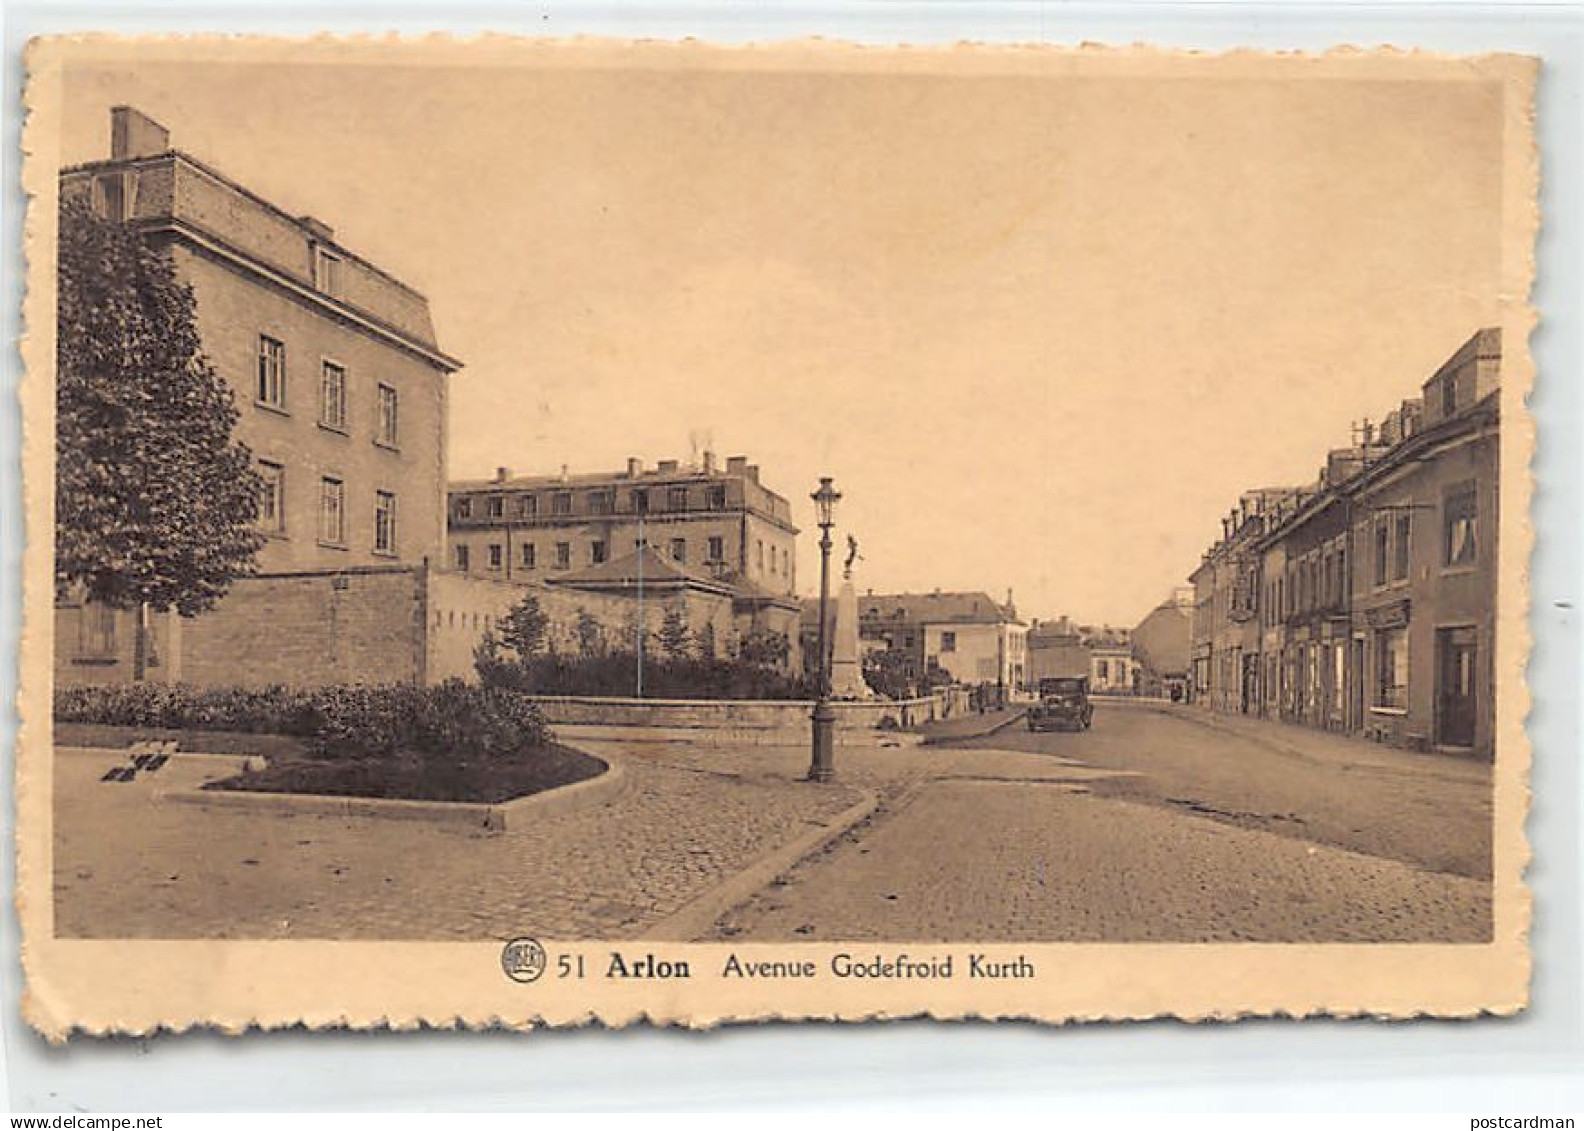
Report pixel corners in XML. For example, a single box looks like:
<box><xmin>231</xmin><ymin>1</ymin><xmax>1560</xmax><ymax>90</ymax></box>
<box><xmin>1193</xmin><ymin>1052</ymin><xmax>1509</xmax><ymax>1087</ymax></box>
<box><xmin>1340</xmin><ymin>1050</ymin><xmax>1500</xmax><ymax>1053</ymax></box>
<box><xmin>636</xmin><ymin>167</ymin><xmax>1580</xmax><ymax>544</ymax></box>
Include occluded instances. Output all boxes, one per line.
<box><xmin>55</xmin><ymin>106</ymin><xmax>459</xmax><ymax>684</ymax></box>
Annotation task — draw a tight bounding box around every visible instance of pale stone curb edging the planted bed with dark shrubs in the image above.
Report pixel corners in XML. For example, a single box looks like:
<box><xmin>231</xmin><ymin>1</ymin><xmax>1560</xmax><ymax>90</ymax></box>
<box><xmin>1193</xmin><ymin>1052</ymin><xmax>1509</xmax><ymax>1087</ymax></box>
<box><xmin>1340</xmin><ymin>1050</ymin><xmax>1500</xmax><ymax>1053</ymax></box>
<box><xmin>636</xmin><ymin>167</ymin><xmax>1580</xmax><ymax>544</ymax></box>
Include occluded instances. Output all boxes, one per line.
<box><xmin>154</xmin><ymin>754</ymin><xmax>627</xmax><ymax>833</ymax></box>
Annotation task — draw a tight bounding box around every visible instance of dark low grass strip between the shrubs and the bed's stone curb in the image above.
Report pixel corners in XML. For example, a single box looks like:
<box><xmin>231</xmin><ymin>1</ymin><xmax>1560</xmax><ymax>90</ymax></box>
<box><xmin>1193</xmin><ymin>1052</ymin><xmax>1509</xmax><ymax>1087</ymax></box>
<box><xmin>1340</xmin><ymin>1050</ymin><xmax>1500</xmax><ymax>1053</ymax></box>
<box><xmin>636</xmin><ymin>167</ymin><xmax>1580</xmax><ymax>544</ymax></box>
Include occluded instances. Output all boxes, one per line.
<box><xmin>204</xmin><ymin>743</ymin><xmax>608</xmax><ymax>805</ymax></box>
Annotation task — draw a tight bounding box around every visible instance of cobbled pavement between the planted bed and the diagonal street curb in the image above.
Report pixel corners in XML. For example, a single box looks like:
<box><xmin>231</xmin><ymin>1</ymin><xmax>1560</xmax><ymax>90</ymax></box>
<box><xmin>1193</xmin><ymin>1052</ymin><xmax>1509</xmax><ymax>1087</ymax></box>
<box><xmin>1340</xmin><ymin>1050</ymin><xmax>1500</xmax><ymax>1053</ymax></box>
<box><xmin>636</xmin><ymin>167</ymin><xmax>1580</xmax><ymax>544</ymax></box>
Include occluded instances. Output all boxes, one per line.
<box><xmin>55</xmin><ymin>751</ymin><xmax>862</xmax><ymax>939</ymax></box>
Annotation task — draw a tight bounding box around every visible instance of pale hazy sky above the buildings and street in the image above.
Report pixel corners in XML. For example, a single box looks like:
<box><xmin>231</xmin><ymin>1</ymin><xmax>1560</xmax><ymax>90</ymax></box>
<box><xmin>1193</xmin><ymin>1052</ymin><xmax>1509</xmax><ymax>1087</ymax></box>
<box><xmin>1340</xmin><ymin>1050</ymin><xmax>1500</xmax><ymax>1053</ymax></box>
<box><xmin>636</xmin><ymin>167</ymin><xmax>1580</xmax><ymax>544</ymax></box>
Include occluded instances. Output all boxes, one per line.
<box><xmin>63</xmin><ymin>43</ymin><xmax>1502</xmax><ymax>624</ymax></box>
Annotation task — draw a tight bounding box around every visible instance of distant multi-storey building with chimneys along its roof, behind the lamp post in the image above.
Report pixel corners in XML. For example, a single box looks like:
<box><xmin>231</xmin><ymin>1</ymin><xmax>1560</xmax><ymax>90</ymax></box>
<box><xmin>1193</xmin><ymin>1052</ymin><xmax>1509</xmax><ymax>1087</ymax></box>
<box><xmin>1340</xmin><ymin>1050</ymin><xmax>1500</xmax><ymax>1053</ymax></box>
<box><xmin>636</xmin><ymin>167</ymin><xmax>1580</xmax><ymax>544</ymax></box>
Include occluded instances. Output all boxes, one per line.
<box><xmin>448</xmin><ymin>451</ymin><xmax>802</xmax><ymax>655</ymax></box>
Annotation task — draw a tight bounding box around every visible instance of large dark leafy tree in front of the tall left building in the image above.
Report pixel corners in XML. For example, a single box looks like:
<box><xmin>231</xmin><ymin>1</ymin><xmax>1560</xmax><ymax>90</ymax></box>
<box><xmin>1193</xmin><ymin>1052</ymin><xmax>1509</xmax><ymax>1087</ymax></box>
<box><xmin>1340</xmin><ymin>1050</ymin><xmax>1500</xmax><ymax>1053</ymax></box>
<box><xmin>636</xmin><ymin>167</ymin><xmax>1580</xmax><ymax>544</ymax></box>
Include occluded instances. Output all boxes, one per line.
<box><xmin>55</xmin><ymin>191</ymin><xmax>263</xmax><ymax>680</ymax></box>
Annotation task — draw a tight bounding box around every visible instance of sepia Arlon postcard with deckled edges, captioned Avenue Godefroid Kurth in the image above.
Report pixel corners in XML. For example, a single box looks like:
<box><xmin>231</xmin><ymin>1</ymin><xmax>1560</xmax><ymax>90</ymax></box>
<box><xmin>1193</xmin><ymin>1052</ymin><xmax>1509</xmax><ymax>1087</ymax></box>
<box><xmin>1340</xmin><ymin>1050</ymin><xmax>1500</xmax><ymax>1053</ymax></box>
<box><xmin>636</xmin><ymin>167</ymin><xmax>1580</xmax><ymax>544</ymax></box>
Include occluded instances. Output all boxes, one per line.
<box><xmin>16</xmin><ymin>36</ymin><xmax>1540</xmax><ymax>1039</ymax></box>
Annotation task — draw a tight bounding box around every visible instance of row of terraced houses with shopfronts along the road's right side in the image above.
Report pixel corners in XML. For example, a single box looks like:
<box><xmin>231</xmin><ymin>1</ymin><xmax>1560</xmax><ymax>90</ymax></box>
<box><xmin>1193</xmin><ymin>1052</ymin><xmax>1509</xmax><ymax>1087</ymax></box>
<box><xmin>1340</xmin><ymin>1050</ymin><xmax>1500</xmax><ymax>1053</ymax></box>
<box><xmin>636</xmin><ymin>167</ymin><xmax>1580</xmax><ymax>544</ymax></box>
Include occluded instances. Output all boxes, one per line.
<box><xmin>1190</xmin><ymin>329</ymin><xmax>1502</xmax><ymax>757</ymax></box>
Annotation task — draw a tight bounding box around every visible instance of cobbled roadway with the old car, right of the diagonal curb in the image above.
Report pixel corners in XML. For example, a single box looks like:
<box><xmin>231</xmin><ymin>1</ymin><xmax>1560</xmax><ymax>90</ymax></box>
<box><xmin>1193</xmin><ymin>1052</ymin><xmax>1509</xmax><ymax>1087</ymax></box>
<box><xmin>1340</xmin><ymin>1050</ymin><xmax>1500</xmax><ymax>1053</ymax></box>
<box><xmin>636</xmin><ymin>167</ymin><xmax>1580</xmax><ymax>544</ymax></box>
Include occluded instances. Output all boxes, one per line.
<box><xmin>711</xmin><ymin>706</ymin><xmax>1491</xmax><ymax>943</ymax></box>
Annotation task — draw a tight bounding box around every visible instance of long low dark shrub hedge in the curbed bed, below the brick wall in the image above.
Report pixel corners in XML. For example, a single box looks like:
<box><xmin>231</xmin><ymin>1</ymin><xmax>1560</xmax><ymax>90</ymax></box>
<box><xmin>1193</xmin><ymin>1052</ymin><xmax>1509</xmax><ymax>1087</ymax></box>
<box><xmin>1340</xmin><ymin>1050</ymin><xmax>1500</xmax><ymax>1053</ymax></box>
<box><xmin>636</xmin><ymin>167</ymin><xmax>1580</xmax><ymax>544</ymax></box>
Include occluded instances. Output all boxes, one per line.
<box><xmin>54</xmin><ymin>680</ymin><xmax>550</xmax><ymax>762</ymax></box>
